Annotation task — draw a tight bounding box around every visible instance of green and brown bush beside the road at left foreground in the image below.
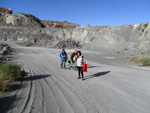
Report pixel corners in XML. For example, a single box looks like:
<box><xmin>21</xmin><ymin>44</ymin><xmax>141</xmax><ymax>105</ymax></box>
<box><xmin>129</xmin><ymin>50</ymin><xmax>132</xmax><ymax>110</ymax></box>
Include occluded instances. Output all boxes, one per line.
<box><xmin>0</xmin><ymin>64</ymin><xmax>21</xmax><ymax>91</ymax></box>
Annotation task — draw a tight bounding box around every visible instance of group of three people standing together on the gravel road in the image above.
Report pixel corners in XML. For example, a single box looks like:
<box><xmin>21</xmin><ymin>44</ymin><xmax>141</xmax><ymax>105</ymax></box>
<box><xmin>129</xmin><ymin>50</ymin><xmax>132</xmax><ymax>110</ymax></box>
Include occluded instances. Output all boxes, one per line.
<box><xmin>60</xmin><ymin>49</ymin><xmax>85</xmax><ymax>80</ymax></box>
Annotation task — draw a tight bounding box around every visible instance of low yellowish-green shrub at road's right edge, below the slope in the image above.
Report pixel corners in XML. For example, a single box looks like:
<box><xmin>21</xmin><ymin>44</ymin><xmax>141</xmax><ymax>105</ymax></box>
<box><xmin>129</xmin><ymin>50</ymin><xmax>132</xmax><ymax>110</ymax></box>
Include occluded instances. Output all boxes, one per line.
<box><xmin>131</xmin><ymin>57</ymin><xmax>150</xmax><ymax>66</ymax></box>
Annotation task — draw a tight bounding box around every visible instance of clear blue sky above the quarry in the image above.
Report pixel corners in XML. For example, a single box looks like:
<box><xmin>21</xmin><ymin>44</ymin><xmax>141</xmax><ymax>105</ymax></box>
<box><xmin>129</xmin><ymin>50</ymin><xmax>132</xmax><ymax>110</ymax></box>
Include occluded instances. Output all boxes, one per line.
<box><xmin>0</xmin><ymin>0</ymin><xmax>150</xmax><ymax>26</ymax></box>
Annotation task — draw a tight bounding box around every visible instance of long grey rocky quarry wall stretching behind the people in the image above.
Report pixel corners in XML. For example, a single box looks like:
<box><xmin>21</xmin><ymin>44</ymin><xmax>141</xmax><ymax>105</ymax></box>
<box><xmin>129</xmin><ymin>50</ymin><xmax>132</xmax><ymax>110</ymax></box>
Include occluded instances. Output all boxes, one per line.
<box><xmin>0</xmin><ymin>8</ymin><xmax>150</xmax><ymax>54</ymax></box>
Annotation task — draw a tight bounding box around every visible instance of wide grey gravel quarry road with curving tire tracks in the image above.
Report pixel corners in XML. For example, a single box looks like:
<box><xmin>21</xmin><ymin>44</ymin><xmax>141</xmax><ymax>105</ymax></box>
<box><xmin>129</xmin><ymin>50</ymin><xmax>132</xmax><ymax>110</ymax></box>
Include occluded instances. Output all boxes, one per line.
<box><xmin>4</xmin><ymin>43</ymin><xmax>150</xmax><ymax>113</ymax></box>
